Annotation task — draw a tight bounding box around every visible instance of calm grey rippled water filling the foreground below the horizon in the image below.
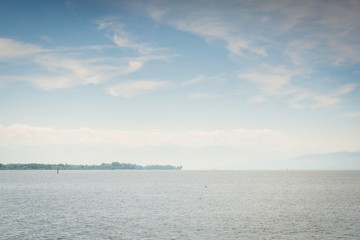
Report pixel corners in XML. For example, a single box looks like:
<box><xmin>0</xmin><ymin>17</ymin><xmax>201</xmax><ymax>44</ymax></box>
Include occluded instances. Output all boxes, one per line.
<box><xmin>0</xmin><ymin>171</ymin><xmax>360</xmax><ymax>239</ymax></box>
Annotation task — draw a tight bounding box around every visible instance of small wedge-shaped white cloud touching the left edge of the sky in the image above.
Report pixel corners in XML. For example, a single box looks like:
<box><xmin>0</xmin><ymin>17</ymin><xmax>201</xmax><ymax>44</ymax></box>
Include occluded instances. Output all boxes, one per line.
<box><xmin>0</xmin><ymin>38</ymin><xmax>47</xmax><ymax>60</ymax></box>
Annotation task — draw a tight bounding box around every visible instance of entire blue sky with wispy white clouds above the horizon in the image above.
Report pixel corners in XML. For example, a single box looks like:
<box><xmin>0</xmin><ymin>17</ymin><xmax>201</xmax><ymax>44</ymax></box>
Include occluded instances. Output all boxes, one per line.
<box><xmin>0</xmin><ymin>0</ymin><xmax>360</xmax><ymax>170</ymax></box>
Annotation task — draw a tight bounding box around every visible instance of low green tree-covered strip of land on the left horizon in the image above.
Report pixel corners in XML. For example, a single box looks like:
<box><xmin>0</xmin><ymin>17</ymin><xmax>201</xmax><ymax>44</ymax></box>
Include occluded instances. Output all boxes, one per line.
<box><xmin>0</xmin><ymin>162</ymin><xmax>182</xmax><ymax>170</ymax></box>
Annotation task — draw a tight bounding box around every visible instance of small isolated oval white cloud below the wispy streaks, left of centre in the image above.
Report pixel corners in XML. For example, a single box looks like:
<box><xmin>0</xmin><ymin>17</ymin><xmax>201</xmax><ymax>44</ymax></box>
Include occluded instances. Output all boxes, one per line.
<box><xmin>107</xmin><ymin>81</ymin><xmax>170</xmax><ymax>97</ymax></box>
